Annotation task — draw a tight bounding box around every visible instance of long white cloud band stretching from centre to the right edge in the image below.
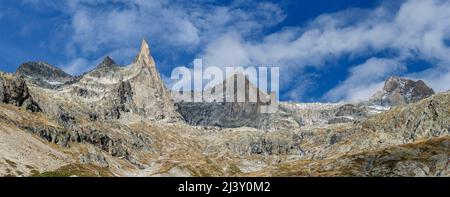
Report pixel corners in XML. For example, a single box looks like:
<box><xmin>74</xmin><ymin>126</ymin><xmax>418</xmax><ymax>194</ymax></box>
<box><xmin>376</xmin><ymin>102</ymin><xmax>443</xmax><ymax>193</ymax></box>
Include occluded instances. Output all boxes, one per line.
<box><xmin>205</xmin><ymin>0</ymin><xmax>450</xmax><ymax>67</ymax></box>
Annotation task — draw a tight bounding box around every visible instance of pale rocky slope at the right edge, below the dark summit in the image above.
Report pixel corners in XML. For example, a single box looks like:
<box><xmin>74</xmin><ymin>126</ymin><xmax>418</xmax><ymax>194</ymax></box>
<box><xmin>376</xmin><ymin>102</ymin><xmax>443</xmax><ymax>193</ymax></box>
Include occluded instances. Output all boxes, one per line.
<box><xmin>362</xmin><ymin>92</ymin><xmax>450</xmax><ymax>144</ymax></box>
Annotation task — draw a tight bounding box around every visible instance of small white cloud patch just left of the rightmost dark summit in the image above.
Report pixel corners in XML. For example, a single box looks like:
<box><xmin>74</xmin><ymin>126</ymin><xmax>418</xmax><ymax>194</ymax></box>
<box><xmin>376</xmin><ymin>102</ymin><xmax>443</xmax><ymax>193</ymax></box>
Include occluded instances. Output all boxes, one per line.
<box><xmin>323</xmin><ymin>58</ymin><xmax>406</xmax><ymax>101</ymax></box>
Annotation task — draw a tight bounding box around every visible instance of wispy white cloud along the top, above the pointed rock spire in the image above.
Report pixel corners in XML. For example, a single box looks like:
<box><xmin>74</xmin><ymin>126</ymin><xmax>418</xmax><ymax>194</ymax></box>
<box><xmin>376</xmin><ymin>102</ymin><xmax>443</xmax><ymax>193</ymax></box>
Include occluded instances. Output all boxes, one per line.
<box><xmin>61</xmin><ymin>0</ymin><xmax>284</xmax><ymax>55</ymax></box>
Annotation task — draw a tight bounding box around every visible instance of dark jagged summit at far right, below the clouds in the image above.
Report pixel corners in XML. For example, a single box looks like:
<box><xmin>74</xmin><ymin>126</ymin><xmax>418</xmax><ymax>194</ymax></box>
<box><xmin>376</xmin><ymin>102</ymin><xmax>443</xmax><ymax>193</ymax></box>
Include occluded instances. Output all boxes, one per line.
<box><xmin>370</xmin><ymin>77</ymin><xmax>434</xmax><ymax>106</ymax></box>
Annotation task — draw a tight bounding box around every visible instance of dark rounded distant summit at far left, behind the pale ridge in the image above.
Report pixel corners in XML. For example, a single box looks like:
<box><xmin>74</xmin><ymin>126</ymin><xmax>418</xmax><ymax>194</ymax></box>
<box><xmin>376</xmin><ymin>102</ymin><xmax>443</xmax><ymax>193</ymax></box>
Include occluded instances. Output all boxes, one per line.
<box><xmin>16</xmin><ymin>61</ymin><xmax>75</xmax><ymax>89</ymax></box>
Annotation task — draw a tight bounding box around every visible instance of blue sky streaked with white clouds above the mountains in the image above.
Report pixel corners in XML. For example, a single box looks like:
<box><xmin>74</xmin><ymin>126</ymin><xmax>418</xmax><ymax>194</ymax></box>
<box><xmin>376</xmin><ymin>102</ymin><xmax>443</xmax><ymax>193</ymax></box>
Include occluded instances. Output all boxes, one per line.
<box><xmin>0</xmin><ymin>0</ymin><xmax>450</xmax><ymax>102</ymax></box>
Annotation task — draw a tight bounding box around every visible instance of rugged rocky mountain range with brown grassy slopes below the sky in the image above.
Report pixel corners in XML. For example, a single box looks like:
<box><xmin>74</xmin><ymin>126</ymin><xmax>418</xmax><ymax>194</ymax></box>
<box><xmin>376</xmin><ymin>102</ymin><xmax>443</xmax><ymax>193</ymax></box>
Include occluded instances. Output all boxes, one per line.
<box><xmin>0</xmin><ymin>40</ymin><xmax>450</xmax><ymax>176</ymax></box>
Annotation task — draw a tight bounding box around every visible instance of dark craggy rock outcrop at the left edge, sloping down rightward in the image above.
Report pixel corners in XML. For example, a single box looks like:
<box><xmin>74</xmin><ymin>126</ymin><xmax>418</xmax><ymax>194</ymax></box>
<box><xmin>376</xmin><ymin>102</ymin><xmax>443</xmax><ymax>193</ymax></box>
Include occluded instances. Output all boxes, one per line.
<box><xmin>0</xmin><ymin>73</ymin><xmax>41</xmax><ymax>112</ymax></box>
